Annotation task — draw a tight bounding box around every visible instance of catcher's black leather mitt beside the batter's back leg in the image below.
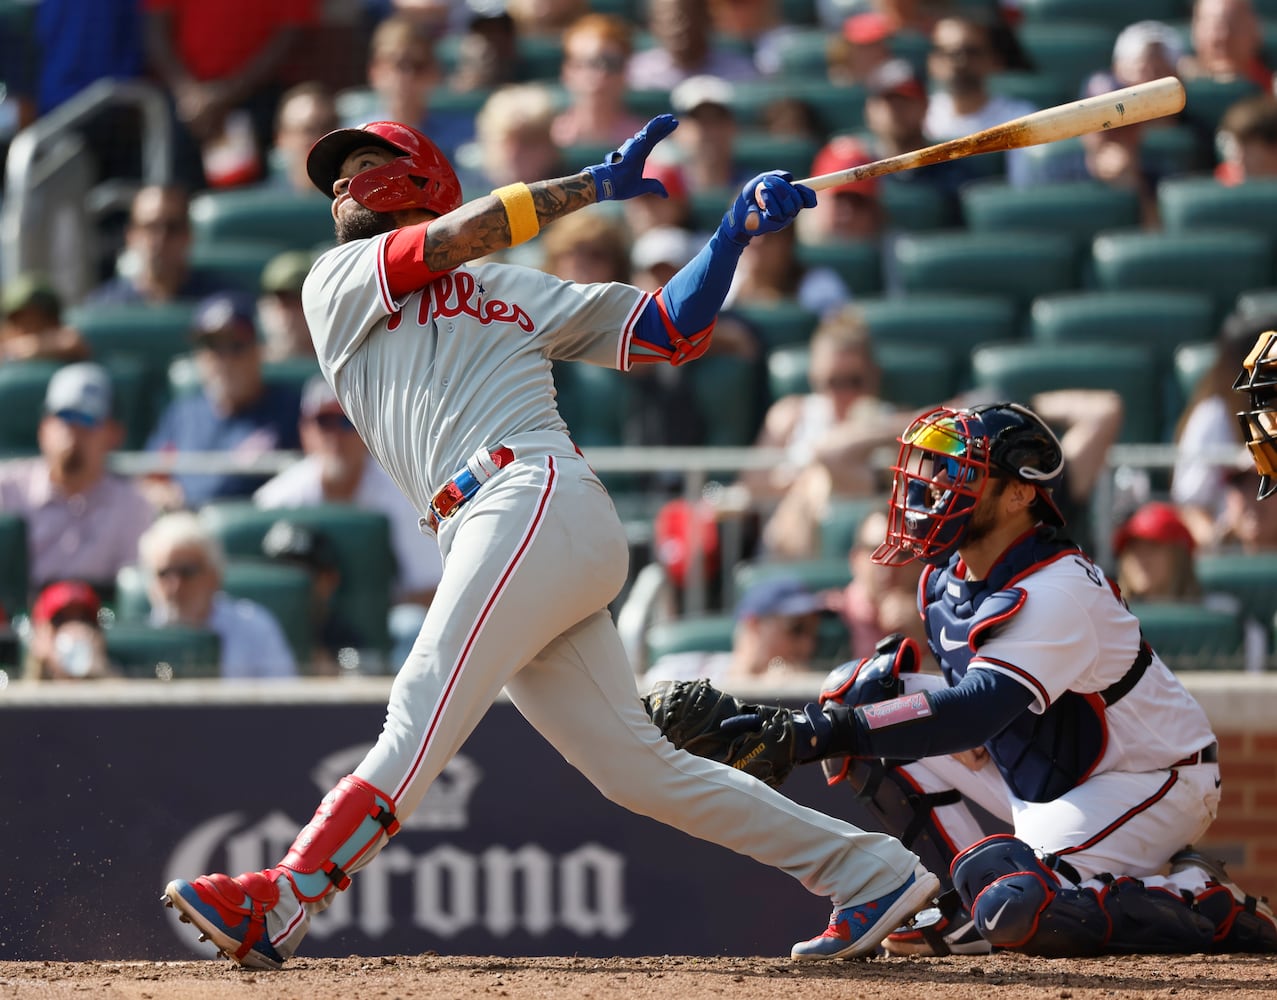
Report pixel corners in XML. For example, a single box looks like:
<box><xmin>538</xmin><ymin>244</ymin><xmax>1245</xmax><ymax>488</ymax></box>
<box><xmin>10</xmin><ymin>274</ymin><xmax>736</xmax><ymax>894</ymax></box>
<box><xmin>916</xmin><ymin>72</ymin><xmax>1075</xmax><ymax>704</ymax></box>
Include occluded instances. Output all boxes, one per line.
<box><xmin>642</xmin><ymin>681</ymin><xmax>794</xmax><ymax>788</ymax></box>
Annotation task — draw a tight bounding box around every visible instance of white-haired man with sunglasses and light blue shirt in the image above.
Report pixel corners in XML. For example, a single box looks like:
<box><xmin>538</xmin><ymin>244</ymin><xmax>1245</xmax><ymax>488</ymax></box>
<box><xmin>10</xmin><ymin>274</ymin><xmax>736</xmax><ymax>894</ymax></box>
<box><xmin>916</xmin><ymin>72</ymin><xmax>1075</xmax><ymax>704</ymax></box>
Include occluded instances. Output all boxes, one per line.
<box><xmin>138</xmin><ymin>511</ymin><xmax>298</xmax><ymax>679</ymax></box>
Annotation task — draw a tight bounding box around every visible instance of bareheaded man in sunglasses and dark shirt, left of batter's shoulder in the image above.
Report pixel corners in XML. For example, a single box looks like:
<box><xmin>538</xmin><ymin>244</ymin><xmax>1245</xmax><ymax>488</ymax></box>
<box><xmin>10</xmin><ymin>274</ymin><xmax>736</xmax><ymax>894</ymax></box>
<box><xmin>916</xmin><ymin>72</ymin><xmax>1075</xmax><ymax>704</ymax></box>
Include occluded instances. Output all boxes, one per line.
<box><xmin>86</xmin><ymin>184</ymin><xmax>232</xmax><ymax>305</ymax></box>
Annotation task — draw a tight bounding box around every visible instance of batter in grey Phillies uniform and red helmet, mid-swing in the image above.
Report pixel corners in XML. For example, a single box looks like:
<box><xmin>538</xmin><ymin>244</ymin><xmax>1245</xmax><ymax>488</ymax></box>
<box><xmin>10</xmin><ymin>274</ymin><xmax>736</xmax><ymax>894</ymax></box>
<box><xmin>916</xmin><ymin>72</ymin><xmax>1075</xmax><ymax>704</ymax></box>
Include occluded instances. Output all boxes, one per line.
<box><xmin>165</xmin><ymin>115</ymin><xmax>939</xmax><ymax>968</ymax></box>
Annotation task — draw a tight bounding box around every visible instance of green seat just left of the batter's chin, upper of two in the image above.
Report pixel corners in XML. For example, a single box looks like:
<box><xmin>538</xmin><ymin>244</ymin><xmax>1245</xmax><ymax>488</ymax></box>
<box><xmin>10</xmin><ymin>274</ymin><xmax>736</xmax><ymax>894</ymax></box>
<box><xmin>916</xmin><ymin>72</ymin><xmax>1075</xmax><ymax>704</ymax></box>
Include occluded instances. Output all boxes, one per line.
<box><xmin>190</xmin><ymin>189</ymin><xmax>337</xmax><ymax>252</ymax></box>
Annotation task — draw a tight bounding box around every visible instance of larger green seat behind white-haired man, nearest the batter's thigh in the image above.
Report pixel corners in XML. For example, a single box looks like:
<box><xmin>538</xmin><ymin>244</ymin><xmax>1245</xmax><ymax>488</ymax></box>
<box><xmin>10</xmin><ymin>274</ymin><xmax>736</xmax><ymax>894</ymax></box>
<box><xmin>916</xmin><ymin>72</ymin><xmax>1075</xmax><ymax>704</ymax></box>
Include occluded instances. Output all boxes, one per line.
<box><xmin>199</xmin><ymin>501</ymin><xmax>395</xmax><ymax>653</ymax></box>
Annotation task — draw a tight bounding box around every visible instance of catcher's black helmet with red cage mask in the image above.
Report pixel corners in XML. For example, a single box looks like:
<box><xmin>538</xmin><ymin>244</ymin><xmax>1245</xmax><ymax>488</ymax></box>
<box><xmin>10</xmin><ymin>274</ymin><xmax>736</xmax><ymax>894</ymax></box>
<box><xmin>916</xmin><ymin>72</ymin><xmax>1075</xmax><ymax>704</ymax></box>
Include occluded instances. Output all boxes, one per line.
<box><xmin>873</xmin><ymin>402</ymin><xmax>1064</xmax><ymax>566</ymax></box>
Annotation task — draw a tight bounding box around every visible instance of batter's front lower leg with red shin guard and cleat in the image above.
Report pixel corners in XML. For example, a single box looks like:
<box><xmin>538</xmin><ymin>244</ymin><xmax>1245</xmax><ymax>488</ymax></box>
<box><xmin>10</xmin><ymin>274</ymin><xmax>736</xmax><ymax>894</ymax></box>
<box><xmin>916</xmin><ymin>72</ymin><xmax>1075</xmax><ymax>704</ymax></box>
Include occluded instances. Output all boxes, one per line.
<box><xmin>162</xmin><ymin>774</ymin><xmax>398</xmax><ymax>969</ymax></box>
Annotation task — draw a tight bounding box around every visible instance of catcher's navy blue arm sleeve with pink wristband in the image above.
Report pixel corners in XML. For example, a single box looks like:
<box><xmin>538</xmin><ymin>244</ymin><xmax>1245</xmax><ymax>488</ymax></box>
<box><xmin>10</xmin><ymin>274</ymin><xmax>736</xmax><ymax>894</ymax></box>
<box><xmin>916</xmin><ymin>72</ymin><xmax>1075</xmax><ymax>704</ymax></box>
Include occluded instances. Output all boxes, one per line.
<box><xmin>850</xmin><ymin>669</ymin><xmax>1033</xmax><ymax>760</ymax></box>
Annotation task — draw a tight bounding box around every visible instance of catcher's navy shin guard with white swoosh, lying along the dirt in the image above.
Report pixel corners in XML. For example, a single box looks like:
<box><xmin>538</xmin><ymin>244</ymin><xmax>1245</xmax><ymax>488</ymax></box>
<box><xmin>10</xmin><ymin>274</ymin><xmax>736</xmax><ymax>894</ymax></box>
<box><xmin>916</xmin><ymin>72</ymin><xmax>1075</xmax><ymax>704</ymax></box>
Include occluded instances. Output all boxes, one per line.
<box><xmin>953</xmin><ymin>834</ymin><xmax>1214</xmax><ymax>958</ymax></box>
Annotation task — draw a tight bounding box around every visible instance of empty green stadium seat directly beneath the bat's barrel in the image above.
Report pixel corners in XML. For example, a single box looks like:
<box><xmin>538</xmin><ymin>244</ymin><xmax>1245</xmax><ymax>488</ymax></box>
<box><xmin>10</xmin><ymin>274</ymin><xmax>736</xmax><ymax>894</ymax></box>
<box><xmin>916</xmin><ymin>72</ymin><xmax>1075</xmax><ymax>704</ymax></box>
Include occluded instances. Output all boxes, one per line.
<box><xmin>960</xmin><ymin>180</ymin><xmax>1140</xmax><ymax>254</ymax></box>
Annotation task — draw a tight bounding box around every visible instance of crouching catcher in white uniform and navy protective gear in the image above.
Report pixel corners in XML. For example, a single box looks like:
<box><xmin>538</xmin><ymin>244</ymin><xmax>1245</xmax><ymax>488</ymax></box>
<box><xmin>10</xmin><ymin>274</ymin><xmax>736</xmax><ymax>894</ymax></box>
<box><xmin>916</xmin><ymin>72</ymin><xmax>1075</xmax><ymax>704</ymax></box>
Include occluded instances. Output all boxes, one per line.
<box><xmin>647</xmin><ymin>403</ymin><xmax>1277</xmax><ymax>957</ymax></box>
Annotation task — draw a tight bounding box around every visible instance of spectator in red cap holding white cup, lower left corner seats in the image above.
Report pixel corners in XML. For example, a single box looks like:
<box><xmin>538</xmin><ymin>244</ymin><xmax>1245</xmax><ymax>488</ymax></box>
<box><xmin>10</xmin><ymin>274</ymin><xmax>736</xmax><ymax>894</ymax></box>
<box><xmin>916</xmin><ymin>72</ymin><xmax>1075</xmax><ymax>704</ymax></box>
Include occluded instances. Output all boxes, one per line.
<box><xmin>23</xmin><ymin>580</ymin><xmax>117</xmax><ymax>681</ymax></box>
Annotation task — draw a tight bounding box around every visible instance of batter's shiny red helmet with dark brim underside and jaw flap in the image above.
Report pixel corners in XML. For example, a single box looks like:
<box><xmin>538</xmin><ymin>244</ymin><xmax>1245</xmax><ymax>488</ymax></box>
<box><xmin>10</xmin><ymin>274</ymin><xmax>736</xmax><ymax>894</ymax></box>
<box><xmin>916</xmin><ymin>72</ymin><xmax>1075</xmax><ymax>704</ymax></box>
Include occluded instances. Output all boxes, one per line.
<box><xmin>306</xmin><ymin>121</ymin><xmax>461</xmax><ymax>216</ymax></box>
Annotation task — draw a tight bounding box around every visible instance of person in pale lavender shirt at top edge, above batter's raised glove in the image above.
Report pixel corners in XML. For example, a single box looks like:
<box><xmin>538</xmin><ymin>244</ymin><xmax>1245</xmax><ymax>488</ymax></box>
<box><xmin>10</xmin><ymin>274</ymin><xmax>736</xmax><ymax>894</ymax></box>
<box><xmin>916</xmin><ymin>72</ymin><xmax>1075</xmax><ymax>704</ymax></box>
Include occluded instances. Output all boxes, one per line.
<box><xmin>626</xmin><ymin>0</ymin><xmax>759</xmax><ymax>91</ymax></box>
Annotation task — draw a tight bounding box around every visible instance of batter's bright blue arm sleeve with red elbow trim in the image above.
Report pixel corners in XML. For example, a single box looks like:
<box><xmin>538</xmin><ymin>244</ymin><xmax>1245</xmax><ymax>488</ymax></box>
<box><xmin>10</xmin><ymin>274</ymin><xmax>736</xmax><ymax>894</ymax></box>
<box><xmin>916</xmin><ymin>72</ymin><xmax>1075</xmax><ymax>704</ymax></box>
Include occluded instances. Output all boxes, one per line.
<box><xmin>630</xmin><ymin>231</ymin><xmax>744</xmax><ymax>365</ymax></box>
